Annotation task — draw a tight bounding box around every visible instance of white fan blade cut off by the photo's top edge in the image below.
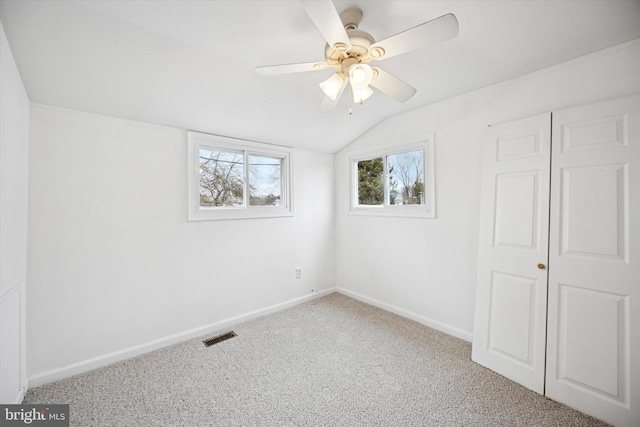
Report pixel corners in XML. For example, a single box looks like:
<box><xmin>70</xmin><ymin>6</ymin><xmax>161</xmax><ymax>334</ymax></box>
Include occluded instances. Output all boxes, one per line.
<box><xmin>300</xmin><ymin>0</ymin><xmax>351</xmax><ymax>52</ymax></box>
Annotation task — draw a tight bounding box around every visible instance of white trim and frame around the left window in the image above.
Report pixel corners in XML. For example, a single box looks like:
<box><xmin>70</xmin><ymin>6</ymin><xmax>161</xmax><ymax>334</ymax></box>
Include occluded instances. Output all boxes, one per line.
<box><xmin>187</xmin><ymin>131</ymin><xmax>293</xmax><ymax>221</ymax></box>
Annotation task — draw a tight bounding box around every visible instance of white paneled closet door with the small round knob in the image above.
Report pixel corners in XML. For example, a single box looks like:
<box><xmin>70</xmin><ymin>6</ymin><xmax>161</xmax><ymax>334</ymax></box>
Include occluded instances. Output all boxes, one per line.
<box><xmin>472</xmin><ymin>114</ymin><xmax>551</xmax><ymax>393</ymax></box>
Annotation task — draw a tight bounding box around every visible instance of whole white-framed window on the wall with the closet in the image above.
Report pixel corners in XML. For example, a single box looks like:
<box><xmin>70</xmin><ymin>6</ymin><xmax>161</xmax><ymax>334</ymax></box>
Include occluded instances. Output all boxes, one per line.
<box><xmin>350</xmin><ymin>139</ymin><xmax>435</xmax><ymax>218</ymax></box>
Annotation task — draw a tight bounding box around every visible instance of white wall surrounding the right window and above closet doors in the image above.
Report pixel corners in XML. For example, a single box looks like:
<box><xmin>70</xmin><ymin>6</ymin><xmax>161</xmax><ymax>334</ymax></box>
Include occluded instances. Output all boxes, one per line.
<box><xmin>336</xmin><ymin>40</ymin><xmax>640</xmax><ymax>340</ymax></box>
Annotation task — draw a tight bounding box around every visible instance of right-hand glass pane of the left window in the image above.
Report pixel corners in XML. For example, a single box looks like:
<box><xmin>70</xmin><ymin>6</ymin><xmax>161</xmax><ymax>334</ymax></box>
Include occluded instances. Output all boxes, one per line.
<box><xmin>249</xmin><ymin>155</ymin><xmax>283</xmax><ymax>206</ymax></box>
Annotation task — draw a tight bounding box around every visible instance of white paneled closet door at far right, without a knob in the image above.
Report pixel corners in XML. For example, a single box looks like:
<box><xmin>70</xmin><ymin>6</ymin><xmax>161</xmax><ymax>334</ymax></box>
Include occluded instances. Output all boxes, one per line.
<box><xmin>546</xmin><ymin>97</ymin><xmax>640</xmax><ymax>426</ymax></box>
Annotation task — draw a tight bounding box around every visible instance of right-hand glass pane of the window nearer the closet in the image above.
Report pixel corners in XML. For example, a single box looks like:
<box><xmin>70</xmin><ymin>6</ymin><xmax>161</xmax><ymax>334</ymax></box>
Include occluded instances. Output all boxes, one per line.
<box><xmin>387</xmin><ymin>150</ymin><xmax>425</xmax><ymax>205</ymax></box>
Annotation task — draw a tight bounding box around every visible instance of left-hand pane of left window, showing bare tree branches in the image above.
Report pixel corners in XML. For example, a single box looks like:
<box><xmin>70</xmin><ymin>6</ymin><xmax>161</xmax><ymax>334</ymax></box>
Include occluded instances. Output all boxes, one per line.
<box><xmin>199</xmin><ymin>148</ymin><xmax>244</xmax><ymax>208</ymax></box>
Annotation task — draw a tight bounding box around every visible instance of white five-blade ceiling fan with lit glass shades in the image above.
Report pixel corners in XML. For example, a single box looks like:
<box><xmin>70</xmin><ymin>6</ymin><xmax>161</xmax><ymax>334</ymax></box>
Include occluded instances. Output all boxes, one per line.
<box><xmin>255</xmin><ymin>0</ymin><xmax>458</xmax><ymax>110</ymax></box>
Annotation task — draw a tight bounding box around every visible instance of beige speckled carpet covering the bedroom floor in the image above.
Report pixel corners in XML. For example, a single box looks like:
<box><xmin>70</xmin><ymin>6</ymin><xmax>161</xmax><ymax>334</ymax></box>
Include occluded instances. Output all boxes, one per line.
<box><xmin>24</xmin><ymin>294</ymin><xmax>606</xmax><ymax>427</ymax></box>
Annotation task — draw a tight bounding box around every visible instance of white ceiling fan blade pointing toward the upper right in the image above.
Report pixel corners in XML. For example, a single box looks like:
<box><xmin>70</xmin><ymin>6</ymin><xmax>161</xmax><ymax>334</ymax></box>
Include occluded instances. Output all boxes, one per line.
<box><xmin>369</xmin><ymin>13</ymin><xmax>458</xmax><ymax>59</ymax></box>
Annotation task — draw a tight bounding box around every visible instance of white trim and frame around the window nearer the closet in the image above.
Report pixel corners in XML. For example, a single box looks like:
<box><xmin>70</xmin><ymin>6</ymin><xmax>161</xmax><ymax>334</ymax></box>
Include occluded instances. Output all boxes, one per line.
<box><xmin>349</xmin><ymin>139</ymin><xmax>436</xmax><ymax>218</ymax></box>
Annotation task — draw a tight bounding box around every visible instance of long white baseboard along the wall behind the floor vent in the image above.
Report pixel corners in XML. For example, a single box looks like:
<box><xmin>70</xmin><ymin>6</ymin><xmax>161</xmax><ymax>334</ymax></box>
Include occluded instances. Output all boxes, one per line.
<box><xmin>28</xmin><ymin>288</ymin><xmax>336</xmax><ymax>388</ymax></box>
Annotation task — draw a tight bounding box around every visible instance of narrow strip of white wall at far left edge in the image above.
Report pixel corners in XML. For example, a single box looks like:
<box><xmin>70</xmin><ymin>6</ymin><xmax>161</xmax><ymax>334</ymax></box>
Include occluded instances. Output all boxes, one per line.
<box><xmin>0</xmin><ymin>20</ymin><xmax>29</xmax><ymax>403</ymax></box>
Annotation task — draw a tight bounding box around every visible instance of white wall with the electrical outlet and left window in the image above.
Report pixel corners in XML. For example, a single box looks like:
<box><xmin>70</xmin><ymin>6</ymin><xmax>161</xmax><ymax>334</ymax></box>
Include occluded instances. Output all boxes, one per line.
<box><xmin>27</xmin><ymin>105</ymin><xmax>335</xmax><ymax>386</ymax></box>
